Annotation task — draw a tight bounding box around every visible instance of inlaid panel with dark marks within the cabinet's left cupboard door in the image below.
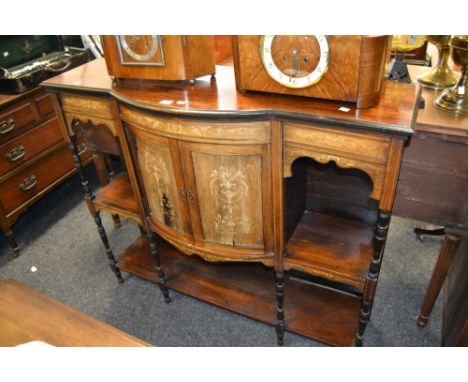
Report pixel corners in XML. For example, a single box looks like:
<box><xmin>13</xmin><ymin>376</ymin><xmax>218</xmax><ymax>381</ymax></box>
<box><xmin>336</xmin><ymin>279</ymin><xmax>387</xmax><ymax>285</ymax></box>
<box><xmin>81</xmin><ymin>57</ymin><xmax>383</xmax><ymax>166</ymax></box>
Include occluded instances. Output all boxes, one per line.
<box><xmin>136</xmin><ymin>137</ymin><xmax>185</xmax><ymax>233</ymax></box>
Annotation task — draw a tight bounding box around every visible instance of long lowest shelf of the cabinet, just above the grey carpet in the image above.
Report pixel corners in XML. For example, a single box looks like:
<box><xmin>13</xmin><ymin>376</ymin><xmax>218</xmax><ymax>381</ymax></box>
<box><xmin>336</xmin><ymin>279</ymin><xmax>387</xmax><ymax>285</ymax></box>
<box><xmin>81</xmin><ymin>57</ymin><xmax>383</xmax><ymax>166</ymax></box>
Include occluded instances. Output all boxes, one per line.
<box><xmin>117</xmin><ymin>237</ymin><xmax>360</xmax><ymax>346</ymax></box>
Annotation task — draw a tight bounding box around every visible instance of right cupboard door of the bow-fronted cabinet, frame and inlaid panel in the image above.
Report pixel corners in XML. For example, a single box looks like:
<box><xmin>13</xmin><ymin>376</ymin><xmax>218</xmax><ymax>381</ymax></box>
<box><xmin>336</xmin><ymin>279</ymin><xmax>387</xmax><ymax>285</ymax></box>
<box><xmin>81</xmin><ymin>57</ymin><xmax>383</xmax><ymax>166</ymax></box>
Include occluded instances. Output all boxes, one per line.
<box><xmin>180</xmin><ymin>142</ymin><xmax>272</xmax><ymax>253</ymax></box>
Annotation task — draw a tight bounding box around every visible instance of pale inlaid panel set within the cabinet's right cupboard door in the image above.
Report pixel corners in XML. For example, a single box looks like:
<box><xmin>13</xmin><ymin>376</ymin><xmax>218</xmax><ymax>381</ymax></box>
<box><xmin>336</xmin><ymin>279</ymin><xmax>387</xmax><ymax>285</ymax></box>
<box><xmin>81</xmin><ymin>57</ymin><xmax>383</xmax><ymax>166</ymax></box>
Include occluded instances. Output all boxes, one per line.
<box><xmin>192</xmin><ymin>151</ymin><xmax>263</xmax><ymax>248</ymax></box>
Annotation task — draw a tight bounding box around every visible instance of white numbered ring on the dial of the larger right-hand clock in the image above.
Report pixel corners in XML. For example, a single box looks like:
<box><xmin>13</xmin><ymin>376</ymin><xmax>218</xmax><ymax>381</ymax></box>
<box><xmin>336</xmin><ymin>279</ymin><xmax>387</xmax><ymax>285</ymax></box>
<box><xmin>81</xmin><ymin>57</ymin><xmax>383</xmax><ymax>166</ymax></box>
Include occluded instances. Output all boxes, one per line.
<box><xmin>260</xmin><ymin>35</ymin><xmax>330</xmax><ymax>89</ymax></box>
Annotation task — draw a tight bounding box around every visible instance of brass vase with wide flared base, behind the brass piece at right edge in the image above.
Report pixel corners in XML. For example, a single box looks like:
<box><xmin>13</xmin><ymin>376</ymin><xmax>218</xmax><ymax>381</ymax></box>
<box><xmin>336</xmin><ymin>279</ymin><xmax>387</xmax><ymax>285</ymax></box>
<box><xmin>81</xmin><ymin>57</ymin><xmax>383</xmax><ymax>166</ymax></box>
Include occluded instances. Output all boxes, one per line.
<box><xmin>418</xmin><ymin>35</ymin><xmax>458</xmax><ymax>90</ymax></box>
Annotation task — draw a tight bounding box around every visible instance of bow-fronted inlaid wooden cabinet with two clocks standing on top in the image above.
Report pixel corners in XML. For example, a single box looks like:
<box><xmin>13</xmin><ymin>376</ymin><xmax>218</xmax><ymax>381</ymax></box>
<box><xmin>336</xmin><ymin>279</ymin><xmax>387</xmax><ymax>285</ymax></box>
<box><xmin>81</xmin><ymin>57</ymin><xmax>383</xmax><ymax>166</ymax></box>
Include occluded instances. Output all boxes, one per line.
<box><xmin>43</xmin><ymin>60</ymin><xmax>418</xmax><ymax>346</ymax></box>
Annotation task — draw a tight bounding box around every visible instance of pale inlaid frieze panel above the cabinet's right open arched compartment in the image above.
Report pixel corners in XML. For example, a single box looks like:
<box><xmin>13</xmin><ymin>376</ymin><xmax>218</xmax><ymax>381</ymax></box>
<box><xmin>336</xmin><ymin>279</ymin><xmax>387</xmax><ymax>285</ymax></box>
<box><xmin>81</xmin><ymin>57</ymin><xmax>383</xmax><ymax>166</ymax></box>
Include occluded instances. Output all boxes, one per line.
<box><xmin>284</xmin><ymin>123</ymin><xmax>390</xmax><ymax>163</ymax></box>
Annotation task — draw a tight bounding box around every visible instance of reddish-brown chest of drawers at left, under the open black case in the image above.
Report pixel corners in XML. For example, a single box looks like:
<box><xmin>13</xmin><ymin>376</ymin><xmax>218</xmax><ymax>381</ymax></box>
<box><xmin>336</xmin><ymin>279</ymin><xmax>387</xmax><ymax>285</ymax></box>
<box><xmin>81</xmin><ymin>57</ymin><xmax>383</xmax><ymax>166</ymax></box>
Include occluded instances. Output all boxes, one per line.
<box><xmin>0</xmin><ymin>88</ymin><xmax>88</xmax><ymax>257</ymax></box>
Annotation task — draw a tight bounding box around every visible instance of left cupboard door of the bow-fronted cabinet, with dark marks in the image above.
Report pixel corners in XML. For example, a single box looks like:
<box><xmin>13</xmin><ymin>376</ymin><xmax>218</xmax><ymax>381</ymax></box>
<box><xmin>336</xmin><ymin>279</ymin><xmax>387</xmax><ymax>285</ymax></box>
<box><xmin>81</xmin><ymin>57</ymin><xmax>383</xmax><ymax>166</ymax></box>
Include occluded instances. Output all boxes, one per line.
<box><xmin>132</xmin><ymin>128</ymin><xmax>192</xmax><ymax>238</ymax></box>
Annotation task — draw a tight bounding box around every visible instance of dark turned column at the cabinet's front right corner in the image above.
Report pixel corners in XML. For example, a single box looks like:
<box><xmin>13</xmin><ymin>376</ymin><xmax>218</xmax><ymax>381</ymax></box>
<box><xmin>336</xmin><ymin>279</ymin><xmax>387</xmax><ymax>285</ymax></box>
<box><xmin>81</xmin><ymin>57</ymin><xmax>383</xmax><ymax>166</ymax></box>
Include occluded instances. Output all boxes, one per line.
<box><xmin>355</xmin><ymin>209</ymin><xmax>391</xmax><ymax>346</ymax></box>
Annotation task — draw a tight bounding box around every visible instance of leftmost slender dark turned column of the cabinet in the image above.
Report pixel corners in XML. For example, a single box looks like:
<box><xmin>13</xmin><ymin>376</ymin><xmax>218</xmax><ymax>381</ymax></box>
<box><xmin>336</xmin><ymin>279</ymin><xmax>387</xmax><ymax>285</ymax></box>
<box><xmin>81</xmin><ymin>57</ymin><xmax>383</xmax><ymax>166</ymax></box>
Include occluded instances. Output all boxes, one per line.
<box><xmin>69</xmin><ymin>120</ymin><xmax>124</xmax><ymax>284</ymax></box>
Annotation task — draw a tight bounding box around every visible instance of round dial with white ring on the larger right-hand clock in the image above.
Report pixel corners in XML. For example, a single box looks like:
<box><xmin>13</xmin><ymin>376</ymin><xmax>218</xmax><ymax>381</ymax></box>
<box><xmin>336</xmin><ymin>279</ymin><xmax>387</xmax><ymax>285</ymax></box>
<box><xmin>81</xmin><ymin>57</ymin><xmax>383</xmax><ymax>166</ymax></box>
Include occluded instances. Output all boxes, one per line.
<box><xmin>260</xmin><ymin>35</ymin><xmax>330</xmax><ymax>89</ymax></box>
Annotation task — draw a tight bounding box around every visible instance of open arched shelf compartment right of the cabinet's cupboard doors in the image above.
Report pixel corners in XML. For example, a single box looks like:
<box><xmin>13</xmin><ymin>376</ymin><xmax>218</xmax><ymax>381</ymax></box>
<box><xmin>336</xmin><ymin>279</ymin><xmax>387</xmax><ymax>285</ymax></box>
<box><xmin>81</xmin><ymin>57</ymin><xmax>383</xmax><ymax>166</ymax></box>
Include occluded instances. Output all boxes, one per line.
<box><xmin>284</xmin><ymin>158</ymin><xmax>378</xmax><ymax>294</ymax></box>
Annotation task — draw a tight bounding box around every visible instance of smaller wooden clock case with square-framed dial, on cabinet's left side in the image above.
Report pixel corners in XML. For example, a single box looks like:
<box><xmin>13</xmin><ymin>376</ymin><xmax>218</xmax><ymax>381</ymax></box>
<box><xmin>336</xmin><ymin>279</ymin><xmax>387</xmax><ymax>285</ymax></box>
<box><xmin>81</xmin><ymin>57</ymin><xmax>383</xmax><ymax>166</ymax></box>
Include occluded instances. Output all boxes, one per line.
<box><xmin>101</xmin><ymin>35</ymin><xmax>215</xmax><ymax>81</ymax></box>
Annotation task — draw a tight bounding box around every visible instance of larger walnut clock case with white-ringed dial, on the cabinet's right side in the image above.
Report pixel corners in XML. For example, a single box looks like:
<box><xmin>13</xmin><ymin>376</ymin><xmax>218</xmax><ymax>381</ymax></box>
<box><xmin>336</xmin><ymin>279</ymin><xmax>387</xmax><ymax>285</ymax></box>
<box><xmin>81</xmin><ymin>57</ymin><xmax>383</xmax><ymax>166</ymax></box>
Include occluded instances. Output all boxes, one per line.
<box><xmin>233</xmin><ymin>35</ymin><xmax>390</xmax><ymax>108</ymax></box>
